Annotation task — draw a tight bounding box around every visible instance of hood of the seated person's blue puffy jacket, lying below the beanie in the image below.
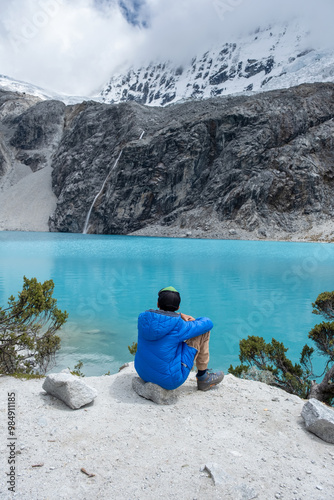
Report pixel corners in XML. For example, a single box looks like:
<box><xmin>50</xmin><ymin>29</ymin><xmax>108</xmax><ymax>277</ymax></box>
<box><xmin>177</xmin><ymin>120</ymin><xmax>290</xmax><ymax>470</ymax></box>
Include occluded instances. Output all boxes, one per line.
<box><xmin>138</xmin><ymin>309</ymin><xmax>182</xmax><ymax>340</ymax></box>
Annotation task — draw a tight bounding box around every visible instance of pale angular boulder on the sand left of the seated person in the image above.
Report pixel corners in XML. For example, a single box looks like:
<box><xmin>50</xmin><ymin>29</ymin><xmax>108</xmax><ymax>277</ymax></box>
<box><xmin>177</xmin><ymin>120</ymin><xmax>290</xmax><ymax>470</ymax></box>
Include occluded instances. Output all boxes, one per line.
<box><xmin>43</xmin><ymin>372</ymin><xmax>97</xmax><ymax>410</ymax></box>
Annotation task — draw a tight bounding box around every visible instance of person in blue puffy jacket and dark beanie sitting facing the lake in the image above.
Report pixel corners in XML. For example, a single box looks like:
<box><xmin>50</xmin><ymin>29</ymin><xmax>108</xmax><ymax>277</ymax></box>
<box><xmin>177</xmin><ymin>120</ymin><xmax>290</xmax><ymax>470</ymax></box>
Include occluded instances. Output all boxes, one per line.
<box><xmin>135</xmin><ymin>286</ymin><xmax>224</xmax><ymax>391</ymax></box>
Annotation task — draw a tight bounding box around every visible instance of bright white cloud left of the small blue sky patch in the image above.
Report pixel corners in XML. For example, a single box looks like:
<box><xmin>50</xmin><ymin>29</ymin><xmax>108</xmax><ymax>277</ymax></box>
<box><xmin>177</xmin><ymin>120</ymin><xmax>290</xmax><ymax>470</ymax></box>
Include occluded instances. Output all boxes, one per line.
<box><xmin>0</xmin><ymin>0</ymin><xmax>143</xmax><ymax>94</ymax></box>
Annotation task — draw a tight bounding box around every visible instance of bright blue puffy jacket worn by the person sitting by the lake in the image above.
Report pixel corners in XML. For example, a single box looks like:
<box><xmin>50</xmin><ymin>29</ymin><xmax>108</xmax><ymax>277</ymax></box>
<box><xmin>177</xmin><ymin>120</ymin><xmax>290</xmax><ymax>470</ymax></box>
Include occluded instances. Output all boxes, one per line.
<box><xmin>135</xmin><ymin>310</ymin><xmax>213</xmax><ymax>390</ymax></box>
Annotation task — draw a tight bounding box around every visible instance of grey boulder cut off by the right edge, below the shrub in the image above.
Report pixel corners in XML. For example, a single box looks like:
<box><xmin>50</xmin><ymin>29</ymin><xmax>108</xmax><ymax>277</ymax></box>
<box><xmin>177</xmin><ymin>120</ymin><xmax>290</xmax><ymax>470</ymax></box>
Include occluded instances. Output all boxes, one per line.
<box><xmin>302</xmin><ymin>399</ymin><xmax>334</xmax><ymax>444</ymax></box>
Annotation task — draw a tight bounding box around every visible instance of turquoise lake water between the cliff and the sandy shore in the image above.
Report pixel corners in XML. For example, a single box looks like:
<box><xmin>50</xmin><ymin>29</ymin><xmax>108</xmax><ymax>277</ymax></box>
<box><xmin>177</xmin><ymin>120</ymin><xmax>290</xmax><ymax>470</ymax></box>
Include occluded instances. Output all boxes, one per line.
<box><xmin>0</xmin><ymin>232</ymin><xmax>334</xmax><ymax>375</ymax></box>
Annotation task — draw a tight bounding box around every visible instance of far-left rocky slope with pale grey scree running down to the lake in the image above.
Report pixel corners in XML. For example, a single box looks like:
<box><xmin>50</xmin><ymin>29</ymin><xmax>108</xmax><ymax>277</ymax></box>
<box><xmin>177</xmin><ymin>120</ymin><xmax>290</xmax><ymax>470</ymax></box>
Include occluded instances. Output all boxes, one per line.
<box><xmin>0</xmin><ymin>90</ymin><xmax>59</xmax><ymax>231</ymax></box>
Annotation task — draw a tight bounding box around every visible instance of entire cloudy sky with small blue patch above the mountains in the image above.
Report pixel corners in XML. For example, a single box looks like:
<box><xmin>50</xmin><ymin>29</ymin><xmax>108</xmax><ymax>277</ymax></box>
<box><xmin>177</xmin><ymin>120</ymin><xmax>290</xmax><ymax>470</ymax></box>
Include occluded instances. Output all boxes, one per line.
<box><xmin>0</xmin><ymin>0</ymin><xmax>334</xmax><ymax>95</ymax></box>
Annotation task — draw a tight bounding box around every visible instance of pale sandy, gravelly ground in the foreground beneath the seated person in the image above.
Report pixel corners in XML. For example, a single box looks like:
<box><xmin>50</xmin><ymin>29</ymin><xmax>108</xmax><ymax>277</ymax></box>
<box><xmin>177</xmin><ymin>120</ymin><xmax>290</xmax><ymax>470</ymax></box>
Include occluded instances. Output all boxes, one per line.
<box><xmin>0</xmin><ymin>364</ymin><xmax>334</xmax><ymax>500</ymax></box>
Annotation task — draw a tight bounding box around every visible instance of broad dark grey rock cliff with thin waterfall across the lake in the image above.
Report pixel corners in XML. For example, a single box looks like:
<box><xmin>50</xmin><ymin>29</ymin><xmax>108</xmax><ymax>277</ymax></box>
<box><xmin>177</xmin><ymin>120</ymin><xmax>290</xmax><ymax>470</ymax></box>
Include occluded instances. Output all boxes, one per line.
<box><xmin>0</xmin><ymin>83</ymin><xmax>334</xmax><ymax>234</ymax></box>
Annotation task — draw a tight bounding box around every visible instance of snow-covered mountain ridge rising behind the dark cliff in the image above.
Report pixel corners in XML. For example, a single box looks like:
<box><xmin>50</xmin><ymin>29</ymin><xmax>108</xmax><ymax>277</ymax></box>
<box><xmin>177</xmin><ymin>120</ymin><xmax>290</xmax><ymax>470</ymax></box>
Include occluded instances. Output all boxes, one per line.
<box><xmin>100</xmin><ymin>21</ymin><xmax>334</xmax><ymax>106</ymax></box>
